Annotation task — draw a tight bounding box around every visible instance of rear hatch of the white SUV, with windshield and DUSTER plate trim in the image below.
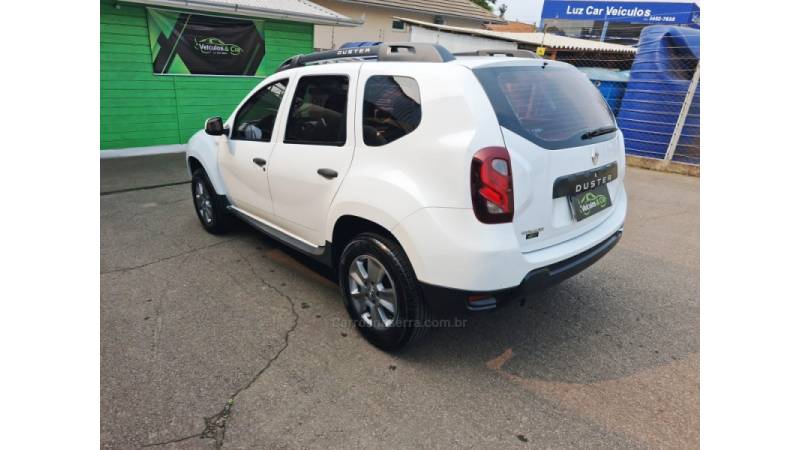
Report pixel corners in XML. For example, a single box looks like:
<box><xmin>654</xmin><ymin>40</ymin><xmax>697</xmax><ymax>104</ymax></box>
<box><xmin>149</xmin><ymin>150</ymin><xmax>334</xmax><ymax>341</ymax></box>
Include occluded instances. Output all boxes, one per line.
<box><xmin>473</xmin><ymin>60</ymin><xmax>625</xmax><ymax>252</ymax></box>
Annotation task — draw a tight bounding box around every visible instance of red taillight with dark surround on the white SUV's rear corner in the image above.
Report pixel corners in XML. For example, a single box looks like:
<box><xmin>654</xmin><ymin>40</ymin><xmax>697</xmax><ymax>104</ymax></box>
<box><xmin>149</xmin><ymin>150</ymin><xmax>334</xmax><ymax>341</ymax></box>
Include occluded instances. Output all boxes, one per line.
<box><xmin>470</xmin><ymin>147</ymin><xmax>514</xmax><ymax>223</ymax></box>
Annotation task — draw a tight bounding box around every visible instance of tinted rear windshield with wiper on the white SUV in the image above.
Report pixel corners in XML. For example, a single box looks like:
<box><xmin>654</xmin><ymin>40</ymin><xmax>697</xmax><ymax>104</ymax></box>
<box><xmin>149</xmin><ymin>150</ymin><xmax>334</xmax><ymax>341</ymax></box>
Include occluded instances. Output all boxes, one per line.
<box><xmin>475</xmin><ymin>65</ymin><xmax>615</xmax><ymax>150</ymax></box>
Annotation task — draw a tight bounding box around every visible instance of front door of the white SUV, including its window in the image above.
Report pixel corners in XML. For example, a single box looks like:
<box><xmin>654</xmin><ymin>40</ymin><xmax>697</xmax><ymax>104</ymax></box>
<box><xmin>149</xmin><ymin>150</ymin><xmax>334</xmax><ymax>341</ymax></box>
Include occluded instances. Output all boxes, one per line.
<box><xmin>219</xmin><ymin>78</ymin><xmax>289</xmax><ymax>218</ymax></box>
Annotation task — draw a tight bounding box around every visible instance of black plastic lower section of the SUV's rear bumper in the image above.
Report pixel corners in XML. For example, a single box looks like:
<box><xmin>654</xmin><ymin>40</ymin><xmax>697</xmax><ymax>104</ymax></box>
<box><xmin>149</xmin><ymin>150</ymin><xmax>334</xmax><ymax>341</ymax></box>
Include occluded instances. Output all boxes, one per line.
<box><xmin>420</xmin><ymin>228</ymin><xmax>622</xmax><ymax>317</ymax></box>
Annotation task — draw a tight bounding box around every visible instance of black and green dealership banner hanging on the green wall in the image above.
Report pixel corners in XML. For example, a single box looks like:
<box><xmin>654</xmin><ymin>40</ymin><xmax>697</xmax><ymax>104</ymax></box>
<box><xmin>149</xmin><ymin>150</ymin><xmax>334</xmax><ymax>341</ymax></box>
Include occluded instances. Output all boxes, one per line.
<box><xmin>147</xmin><ymin>8</ymin><xmax>267</xmax><ymax>76</ymax></box>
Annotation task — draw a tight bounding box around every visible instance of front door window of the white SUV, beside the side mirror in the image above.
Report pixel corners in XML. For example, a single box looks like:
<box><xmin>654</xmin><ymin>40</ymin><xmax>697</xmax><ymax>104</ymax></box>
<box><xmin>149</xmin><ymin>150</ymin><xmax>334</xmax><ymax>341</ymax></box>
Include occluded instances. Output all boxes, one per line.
<box><xmin>231</xmin><ymin>80</ymin><xmax>288</xmax><ymax>142</ymax></box>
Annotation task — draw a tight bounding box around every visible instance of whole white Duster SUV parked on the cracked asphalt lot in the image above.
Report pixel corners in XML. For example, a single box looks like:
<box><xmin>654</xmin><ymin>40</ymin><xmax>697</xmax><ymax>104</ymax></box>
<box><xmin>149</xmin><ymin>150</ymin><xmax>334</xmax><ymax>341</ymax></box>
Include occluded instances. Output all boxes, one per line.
<box><xmin>187</xmin><ymin>43</ymin><xmax>627</xmax><ymax>350</ymax></box>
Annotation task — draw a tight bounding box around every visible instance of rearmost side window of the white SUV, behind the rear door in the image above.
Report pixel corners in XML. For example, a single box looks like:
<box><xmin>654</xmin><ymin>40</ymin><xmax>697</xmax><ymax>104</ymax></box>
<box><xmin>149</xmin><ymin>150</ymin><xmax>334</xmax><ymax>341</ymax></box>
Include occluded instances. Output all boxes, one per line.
<box><xmin>363</xmin><ymin>75</ymin><xmax>422</xmax><ymax>147</ymax></box>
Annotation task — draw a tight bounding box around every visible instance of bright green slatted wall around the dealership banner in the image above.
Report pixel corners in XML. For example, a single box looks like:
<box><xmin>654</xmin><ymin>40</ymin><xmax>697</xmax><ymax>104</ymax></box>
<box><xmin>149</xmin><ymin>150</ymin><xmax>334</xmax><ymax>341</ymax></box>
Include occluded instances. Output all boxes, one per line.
<box><xmin>100</xmin><ymin>0</ymin><xmax>314</xmax><ymax>150</ymax></box>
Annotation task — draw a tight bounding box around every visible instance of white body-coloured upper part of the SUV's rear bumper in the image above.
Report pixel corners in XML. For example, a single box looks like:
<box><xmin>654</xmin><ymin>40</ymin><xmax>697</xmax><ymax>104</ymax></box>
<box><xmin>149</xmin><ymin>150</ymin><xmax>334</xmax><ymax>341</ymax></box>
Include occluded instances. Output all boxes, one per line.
<box><xmin>391</xmin><ymin>186</ymin><xmax>627</xmax><ymax>292</ymax></box>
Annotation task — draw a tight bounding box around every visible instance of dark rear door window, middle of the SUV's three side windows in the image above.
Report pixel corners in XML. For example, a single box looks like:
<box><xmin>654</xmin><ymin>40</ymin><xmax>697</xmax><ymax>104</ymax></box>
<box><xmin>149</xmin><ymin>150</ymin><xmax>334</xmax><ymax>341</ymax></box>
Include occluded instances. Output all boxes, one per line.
<box><xmin>283</xmin><ymin>75</ymin><xmax>349</xmax><ymax>147</ymax></box>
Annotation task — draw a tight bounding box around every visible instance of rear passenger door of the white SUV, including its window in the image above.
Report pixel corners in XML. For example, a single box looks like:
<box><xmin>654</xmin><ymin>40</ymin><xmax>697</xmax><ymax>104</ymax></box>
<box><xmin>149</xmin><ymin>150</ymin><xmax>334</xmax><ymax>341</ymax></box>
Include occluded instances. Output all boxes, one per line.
<box><xmin>267</xmin><ymin>63</ymin><xmax>360</xmax><ymax>246</ymax></box>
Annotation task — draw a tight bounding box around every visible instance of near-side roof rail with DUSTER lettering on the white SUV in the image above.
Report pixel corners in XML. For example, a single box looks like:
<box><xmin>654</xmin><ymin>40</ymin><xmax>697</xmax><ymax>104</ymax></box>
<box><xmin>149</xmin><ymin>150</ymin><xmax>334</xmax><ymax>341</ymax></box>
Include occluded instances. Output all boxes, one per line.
<box><xmin>276</xmin><ymin>42</ymin><xmax>455</xmax><ymax>72</ymax></box>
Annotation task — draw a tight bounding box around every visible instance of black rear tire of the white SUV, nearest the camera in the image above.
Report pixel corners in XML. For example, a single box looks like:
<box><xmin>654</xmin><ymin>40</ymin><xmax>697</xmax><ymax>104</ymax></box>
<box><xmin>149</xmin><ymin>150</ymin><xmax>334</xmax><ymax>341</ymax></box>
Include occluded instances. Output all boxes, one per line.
<box><xmin>339</xmin><ymin>233</ymin><xmax>430</xmax><ymax>351</ymax></box>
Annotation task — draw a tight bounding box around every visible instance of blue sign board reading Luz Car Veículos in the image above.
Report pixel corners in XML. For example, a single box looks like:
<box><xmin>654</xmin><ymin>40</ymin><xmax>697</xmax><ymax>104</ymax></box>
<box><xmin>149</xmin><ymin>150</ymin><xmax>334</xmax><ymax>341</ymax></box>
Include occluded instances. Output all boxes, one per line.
<box><xmin>542</xmin><ymin>0</ymin><xmax>700</xmax><ymax>25</ymax></box>
